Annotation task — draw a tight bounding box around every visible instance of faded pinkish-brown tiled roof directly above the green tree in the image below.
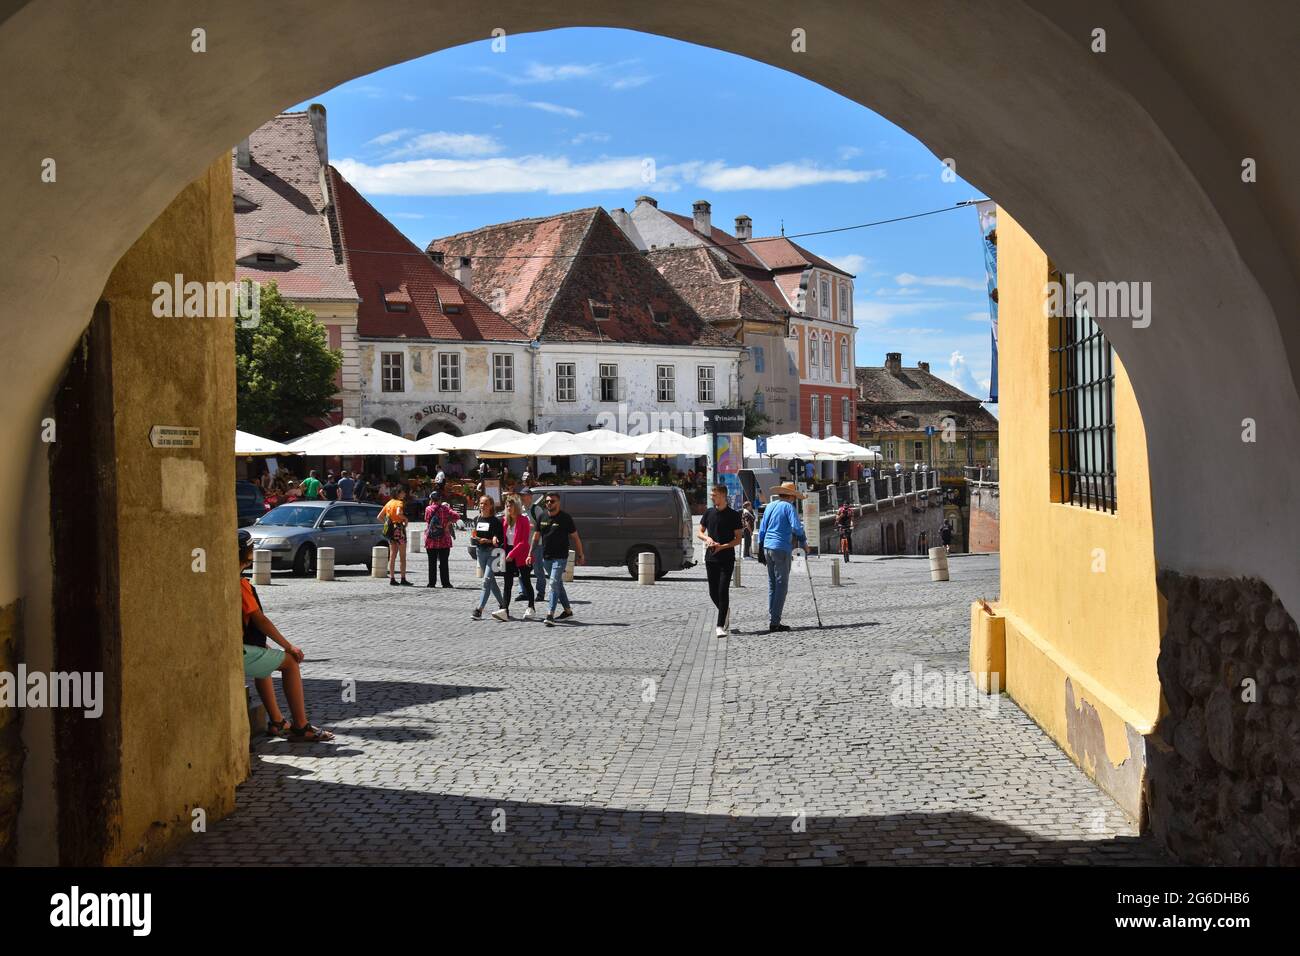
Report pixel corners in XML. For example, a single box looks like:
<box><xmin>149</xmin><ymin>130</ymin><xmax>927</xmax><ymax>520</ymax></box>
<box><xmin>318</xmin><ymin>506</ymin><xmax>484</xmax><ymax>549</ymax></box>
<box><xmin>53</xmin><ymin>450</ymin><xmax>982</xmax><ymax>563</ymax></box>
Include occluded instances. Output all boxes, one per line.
<box><xmin>230</xmin><ymin>113</ymin><xmax>356</xmax><ymax>300</ymax></box>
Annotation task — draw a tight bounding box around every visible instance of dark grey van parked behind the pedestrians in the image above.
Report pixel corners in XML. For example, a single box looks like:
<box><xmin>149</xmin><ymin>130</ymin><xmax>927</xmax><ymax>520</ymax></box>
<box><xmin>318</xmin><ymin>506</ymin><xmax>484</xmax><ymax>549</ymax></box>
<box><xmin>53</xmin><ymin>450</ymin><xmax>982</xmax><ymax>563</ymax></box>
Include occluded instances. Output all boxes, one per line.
<box><xmin>520</xmin><ymin>485</ymin><xmax>696</xmax><ymax>578</ymax></box>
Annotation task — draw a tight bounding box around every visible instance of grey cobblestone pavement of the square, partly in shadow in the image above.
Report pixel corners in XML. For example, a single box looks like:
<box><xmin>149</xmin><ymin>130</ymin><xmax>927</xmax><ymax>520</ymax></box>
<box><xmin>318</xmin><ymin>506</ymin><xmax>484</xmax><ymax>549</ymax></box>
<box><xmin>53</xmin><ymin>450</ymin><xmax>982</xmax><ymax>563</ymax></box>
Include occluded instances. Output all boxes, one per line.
<box><xmin>165</xmin><ymin>538</ymin><xmax>1165</xmax><ymax>865</ymax></box>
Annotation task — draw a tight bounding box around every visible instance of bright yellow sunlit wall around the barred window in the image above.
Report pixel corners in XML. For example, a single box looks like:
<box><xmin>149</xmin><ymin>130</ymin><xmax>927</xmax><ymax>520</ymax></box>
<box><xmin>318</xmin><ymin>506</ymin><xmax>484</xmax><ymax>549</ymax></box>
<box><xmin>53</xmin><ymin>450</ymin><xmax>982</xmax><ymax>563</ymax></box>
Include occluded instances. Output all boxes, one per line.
<box><xmin>977</xmin><ymin>209</ymin><xmax>1161</xmax><ymax>816</ymax></box>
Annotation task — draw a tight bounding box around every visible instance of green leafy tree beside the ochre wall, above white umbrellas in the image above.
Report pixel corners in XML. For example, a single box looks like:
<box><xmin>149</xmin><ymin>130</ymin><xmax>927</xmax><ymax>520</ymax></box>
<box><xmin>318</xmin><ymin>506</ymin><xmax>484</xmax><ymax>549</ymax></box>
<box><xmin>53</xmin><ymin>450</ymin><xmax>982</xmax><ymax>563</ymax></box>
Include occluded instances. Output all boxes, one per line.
<box><xmin>235</xmin><ymin>282</ymin><xmax>343</xmax><ymax>441</ymax></box>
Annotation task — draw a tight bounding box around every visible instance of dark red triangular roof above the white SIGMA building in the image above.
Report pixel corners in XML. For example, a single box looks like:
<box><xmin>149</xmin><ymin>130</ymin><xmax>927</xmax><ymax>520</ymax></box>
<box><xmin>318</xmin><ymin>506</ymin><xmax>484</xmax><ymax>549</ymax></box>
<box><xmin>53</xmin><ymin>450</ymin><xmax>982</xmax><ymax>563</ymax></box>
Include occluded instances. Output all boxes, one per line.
<box><xmin>330</xmin><ymin>166</ymin><xmax>527</xmax><ymax>342</ymax></box>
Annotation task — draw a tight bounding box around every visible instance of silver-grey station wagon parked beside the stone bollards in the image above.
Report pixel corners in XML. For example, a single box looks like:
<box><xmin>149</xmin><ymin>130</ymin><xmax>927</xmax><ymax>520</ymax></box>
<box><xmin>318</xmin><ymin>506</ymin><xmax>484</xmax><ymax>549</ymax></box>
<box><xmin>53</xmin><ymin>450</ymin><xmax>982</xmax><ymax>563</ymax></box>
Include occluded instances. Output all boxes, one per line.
<box><xmin>247</xmin><ymin>501</ymin><xmax>389</xmax><ymax>575</ymax></box>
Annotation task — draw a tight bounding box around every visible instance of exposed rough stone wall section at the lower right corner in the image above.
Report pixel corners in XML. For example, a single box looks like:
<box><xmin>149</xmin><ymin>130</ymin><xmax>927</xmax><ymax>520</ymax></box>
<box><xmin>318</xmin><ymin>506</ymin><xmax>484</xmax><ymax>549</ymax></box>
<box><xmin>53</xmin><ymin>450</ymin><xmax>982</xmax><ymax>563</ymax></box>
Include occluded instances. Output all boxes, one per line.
<box><xmin>1147</xmin><ymin>571</ymin><xmax>1300</xmax><ymax>866</ymax></box>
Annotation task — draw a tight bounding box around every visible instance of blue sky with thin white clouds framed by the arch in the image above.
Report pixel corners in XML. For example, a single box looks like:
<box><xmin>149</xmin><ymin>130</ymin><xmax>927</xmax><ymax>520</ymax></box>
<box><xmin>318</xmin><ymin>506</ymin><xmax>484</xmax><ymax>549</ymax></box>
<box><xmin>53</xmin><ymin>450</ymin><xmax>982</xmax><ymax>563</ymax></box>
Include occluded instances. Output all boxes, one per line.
<box><xmin>295</xmin><ymin>29</ymin><xmax>991</xmax><ymax>398</ymax></box>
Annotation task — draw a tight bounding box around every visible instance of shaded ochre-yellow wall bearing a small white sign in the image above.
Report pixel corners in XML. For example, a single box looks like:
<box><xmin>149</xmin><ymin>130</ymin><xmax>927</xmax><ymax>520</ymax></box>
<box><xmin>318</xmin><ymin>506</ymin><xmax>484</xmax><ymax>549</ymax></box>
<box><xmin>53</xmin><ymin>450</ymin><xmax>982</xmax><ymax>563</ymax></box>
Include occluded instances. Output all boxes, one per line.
<box><xmin>104</xmin><ymin>155</ymin><xmax>248</xmax><ymax>864</ymax></box>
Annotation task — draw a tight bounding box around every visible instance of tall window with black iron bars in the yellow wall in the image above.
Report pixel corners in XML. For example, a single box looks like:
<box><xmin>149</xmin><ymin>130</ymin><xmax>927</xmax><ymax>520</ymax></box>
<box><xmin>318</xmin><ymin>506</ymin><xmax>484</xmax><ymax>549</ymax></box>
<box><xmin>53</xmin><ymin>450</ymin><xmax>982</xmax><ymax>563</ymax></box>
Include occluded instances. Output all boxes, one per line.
<box><xmin>1048</xmin><ymin>271</ymin><xmax>1115</xmax><ymax>512</ymax></box>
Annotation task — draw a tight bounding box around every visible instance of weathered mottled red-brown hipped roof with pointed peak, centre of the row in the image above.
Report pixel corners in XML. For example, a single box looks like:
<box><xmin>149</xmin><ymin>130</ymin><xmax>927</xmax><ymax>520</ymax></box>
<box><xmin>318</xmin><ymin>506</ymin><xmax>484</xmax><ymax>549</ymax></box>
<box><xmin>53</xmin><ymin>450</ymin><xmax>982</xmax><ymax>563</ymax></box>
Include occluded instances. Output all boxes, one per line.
<box><xmin>428</xmin><ymin>207</ymin><xmax>738</xmax><ymax>347</ymax></box>
